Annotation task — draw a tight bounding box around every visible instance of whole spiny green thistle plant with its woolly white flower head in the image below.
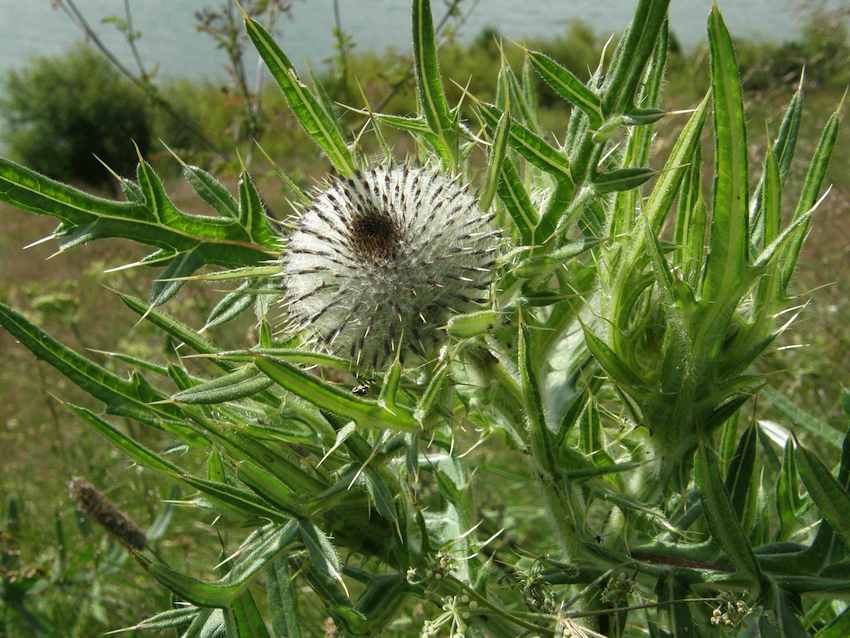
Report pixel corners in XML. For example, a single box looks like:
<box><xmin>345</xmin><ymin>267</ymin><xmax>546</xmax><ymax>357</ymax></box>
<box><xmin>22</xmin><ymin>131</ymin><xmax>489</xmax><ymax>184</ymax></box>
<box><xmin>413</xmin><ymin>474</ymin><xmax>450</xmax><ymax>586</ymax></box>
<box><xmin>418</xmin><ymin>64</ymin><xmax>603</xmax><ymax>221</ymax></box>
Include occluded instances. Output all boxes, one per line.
<box><xmin>0</xmin><ymin>0</ymin><xmax>850</xmax><ymax>638</ymax></box>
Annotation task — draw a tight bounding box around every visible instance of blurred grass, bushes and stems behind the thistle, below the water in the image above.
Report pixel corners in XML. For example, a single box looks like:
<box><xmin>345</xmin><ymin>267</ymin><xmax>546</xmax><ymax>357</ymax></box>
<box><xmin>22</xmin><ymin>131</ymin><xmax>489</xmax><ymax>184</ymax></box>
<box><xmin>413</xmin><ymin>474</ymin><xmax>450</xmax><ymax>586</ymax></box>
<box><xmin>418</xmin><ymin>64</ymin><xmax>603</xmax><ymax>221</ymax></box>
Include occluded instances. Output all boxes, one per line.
<box><xmin>0</xmin><ymin>0</ymin><xmax>850</xmax><ymax>638</ymax></box>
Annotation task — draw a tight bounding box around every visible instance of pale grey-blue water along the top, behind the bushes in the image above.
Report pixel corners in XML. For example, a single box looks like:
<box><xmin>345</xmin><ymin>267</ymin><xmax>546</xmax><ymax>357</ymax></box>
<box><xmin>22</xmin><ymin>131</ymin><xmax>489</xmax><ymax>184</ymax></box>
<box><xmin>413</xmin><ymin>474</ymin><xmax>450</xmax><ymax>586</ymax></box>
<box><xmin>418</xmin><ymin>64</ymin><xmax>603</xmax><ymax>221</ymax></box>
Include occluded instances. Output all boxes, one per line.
<box><xmin>0</xmin><ymin>0</ymin><xmax>842</xmax><ymax>78</ymax></box>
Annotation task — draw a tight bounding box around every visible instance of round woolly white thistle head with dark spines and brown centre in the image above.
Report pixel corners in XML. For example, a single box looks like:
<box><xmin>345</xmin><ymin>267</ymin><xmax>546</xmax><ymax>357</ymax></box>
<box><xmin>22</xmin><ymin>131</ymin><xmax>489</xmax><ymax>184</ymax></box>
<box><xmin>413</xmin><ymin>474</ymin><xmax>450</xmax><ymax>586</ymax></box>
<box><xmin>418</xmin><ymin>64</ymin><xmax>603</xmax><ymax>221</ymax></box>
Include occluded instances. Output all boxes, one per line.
<box><xmin>282</xmin><ymin>165</ymin><xmax>498</xmax><ymax>368</ymax></box>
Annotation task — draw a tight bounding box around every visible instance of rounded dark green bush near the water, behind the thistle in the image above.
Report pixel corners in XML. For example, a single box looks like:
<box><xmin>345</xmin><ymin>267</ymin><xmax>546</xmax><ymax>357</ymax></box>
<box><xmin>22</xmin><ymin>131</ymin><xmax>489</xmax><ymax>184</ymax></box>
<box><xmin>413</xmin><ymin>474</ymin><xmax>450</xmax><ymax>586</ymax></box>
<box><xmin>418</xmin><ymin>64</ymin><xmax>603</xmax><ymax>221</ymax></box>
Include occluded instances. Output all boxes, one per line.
<box><xmin>0</xmin><ymin>46</ymin><xmax>153</xmax><ymax>186</ymax></box>
